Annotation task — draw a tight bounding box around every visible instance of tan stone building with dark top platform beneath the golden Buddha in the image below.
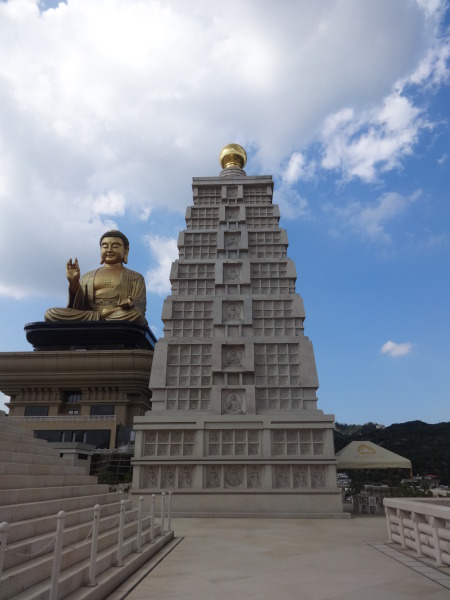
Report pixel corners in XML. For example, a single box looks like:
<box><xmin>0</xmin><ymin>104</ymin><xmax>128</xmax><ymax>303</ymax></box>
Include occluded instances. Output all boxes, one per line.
<box><xmin>0</xmin><ymin>322</ymin><xmax>156</xmax><ymax>449</ymax></box>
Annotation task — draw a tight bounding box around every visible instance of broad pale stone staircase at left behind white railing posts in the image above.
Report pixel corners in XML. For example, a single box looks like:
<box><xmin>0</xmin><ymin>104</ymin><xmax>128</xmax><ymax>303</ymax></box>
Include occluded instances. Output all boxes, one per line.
<box><xmin>0</xmin><ymin>417</ymin><xmax>173</xmax><ymax>600</ymax></box>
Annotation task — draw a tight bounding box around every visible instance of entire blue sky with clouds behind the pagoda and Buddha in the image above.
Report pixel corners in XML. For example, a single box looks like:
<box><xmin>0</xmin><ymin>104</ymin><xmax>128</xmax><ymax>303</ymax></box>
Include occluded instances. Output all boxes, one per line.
<box><xmin>0</xmin><ymin>0</ymin><xmax>450</xmax><ymax>425</ymax></box>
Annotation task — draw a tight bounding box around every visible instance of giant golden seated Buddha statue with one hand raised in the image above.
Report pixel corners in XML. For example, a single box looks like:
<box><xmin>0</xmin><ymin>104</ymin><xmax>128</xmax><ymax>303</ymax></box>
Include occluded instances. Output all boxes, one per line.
<box><xmin>45</xmin><ymin>230</ymin><xmax>147</xmax><ymax>325</ymax></box>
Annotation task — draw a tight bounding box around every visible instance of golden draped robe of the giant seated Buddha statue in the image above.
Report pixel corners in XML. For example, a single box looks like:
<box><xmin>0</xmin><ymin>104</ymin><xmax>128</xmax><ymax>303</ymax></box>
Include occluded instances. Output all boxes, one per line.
<box><xmin>45</xmin><ymin>267</ymin><xmax>147</xmax><ymax>325</ymax></box>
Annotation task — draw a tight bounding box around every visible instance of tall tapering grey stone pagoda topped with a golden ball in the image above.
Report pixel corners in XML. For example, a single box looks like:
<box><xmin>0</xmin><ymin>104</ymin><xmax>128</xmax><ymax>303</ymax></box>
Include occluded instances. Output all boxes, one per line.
<box><xmin>133</xmin><ymin>144</ymin><xmax>342</xmax><ymax>517</ymax></box>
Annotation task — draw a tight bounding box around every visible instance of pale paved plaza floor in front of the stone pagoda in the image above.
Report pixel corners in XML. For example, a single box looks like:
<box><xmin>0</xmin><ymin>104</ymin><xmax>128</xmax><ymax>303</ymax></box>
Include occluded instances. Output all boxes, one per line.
<box><xmin>110</xmin><ymin>515</ymin><xmax>450</xmax><ymax>600</ymax></box>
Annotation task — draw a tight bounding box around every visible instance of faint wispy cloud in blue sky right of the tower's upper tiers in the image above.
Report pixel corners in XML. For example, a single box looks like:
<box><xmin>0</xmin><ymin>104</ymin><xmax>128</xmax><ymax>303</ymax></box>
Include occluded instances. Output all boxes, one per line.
<box><xmin>324</xmin><ymin>190</ymin><xmax>421</xmax><ymax>243</ymax></box>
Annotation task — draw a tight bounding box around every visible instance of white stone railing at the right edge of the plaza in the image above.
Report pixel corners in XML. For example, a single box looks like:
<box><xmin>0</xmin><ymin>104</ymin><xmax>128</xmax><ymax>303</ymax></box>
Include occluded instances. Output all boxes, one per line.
<box><xmin>383</xmin><ymin>498</ymin><xmax>450</xmax><ymax>566</ymax></box>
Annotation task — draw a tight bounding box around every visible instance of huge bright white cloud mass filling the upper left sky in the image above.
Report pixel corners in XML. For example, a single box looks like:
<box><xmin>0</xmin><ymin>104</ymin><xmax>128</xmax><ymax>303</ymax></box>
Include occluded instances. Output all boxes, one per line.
<box><xmin>0</xmin><ymin>0</ymin><xmax>448</xmax><ymax>297</ymax></box>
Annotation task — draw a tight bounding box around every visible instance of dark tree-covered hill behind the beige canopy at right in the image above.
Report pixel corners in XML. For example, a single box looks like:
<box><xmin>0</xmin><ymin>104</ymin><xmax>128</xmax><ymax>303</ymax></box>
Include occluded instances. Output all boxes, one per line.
<box><xmin>334</xmin><ymin>421</ymin><xmax>450</xmax><ymax>485</ymax></box>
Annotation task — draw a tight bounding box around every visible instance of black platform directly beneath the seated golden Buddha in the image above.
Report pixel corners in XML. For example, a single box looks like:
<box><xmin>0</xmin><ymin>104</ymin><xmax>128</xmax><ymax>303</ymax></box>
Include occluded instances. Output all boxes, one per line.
<box><xmin>24</xmin><ymin>321</ymin><xmax>157</xmax><ymax>350</ymax></box>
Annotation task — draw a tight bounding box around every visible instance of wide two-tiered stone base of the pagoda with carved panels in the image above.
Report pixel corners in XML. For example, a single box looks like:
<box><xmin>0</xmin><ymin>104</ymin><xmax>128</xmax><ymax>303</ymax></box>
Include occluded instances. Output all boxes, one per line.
<box><xmin>131</xmin><ymin>410</ymin><xmax>348</xmax><ymax>518</ymax></box>
